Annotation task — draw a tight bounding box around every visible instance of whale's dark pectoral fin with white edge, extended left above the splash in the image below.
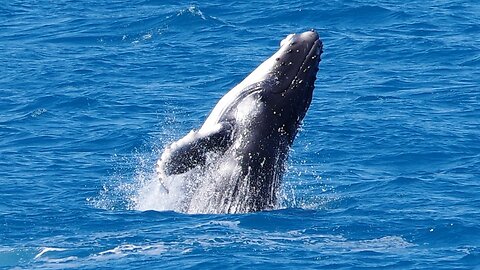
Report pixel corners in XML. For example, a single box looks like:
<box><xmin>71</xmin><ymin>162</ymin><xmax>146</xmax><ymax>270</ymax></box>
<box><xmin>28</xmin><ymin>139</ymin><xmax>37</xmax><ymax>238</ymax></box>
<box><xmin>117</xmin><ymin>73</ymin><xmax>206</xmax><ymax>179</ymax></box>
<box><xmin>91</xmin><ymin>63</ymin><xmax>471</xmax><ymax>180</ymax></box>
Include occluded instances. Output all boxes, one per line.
<box><xmin>157</xmin><ymin>122</ymin><xmax>232</xmax><ymax>175</ymax></box>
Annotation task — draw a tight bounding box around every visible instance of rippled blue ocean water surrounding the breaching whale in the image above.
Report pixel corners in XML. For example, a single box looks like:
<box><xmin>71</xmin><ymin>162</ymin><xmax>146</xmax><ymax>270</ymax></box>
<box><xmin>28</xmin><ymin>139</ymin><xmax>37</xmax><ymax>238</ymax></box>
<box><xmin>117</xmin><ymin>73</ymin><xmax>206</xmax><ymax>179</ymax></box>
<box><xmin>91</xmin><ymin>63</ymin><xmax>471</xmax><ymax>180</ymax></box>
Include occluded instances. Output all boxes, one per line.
<box><xmin>0</xmin><ymin>0</ymin><xmax>480</xmax><ymax>269</ymax></box>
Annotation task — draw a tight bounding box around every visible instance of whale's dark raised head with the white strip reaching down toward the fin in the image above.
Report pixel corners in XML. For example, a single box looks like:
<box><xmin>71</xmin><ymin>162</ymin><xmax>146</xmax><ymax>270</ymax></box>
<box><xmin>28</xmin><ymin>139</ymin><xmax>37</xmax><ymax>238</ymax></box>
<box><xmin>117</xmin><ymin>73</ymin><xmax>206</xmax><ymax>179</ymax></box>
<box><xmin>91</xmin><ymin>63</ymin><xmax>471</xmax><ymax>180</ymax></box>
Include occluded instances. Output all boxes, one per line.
<box><xmin>202</xmin><ymin>30</ymin><xmax>323</xmax><ymax>136</ymax></box>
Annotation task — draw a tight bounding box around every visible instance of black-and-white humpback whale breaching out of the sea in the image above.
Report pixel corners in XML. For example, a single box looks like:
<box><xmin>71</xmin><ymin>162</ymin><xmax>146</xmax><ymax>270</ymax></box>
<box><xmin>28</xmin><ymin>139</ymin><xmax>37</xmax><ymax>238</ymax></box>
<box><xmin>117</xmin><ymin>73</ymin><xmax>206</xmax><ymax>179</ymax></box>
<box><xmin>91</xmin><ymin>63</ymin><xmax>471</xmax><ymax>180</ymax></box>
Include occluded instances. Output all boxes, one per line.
<box><xmin>156</xmin><ymin>30</ymin><xmax>323</xmax><ymax>213</ymax></box>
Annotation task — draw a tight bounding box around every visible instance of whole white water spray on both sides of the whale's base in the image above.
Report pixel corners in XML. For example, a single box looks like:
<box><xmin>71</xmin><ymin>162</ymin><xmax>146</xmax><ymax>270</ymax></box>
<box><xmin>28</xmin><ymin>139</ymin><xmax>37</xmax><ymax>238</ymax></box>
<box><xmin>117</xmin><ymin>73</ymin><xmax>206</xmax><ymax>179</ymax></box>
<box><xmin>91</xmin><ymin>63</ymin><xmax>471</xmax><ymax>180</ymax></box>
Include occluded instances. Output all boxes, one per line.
<box><xmin>87</xmin><ymin>134</ymin><xmax>330</xmax><ymax>214</ymax></box>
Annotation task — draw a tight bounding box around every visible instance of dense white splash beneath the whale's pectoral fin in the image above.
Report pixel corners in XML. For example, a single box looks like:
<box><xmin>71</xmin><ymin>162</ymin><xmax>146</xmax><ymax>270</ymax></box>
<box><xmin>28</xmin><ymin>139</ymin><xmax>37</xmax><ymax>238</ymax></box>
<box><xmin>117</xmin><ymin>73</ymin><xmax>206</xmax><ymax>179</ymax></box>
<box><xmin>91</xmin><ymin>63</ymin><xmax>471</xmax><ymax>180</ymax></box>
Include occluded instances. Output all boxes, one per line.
<box><xmin>132</xmin><ymin>149</ymin><xmax>270</xmax><ymax>213</ymax></box>
